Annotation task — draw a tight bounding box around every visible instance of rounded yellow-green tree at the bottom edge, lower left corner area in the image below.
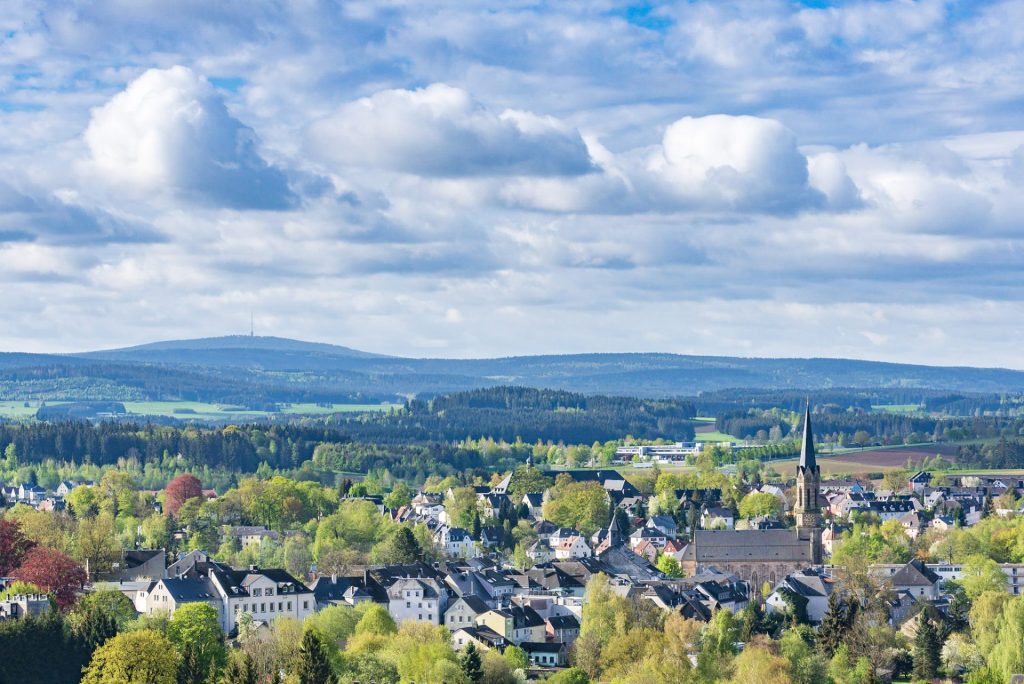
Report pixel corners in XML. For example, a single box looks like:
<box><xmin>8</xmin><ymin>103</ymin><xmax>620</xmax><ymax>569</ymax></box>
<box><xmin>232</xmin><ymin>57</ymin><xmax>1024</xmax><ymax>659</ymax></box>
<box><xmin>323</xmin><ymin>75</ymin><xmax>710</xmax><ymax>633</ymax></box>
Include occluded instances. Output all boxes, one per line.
<box><xmin>82</xmin><ymin>630</ymin><xmax>179</xmax><ymax>684</ymax></box>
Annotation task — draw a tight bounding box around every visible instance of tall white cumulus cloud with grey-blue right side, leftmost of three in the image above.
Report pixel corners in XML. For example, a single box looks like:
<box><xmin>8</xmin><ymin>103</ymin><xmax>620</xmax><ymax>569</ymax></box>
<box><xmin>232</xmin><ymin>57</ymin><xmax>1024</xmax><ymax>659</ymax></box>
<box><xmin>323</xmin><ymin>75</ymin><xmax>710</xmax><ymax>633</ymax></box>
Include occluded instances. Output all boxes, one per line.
<box><xmin>85</xmin><ymin>67</ymin><xmax>296</xmax><ymax>209</ymax></box>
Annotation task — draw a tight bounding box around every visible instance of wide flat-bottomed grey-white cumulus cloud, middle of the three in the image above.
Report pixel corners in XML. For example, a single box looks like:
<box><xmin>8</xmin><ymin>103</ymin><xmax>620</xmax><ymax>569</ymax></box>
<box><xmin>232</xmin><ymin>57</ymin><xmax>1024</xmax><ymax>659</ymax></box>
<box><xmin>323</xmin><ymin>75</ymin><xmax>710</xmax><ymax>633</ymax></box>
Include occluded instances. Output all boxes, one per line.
<box><xmin>309</xmin><ymin>83</ymin><xmax>594</xmax><ymax>176</ymax></box>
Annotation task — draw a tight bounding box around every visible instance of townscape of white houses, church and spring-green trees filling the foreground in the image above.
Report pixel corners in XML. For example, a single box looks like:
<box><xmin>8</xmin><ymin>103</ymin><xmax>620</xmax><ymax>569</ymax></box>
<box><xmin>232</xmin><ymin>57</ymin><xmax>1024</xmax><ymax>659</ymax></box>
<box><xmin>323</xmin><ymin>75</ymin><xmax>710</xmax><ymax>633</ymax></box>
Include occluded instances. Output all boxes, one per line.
<box><xmin>6</xmin><ymin>405</ymin><xmax>1024</xmax><ymax>684</ymax></box>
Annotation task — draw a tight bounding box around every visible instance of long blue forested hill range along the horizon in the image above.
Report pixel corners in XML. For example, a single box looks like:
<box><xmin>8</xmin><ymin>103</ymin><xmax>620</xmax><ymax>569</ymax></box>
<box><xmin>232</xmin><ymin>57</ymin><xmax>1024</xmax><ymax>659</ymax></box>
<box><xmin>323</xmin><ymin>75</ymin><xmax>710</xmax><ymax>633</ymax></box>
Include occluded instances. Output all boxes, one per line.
<box><xmin>0</xmin><ymin>336</ymin><xmax>1024</xmax><ymax>405</ymax></box>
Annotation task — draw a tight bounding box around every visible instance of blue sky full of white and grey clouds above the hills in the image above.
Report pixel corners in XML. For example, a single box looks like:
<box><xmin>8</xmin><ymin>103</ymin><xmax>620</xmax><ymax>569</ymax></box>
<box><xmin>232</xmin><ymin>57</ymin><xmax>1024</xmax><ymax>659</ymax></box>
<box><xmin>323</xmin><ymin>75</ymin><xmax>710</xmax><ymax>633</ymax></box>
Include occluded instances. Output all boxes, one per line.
<box><xmin>0</xmin><ymin>0</ymin><xmax>1024</xmax><ymax>368</ymax></box>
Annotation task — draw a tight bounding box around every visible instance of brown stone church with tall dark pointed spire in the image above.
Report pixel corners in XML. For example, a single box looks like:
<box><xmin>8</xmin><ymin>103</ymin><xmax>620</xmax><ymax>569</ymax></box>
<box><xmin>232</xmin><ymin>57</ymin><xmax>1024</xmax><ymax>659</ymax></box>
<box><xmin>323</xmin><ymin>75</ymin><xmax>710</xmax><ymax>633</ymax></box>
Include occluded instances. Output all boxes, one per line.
<box><xmin>680</xmin><ymin>405</ymin><xmax>821</xmax><ymax>591</ymax></box>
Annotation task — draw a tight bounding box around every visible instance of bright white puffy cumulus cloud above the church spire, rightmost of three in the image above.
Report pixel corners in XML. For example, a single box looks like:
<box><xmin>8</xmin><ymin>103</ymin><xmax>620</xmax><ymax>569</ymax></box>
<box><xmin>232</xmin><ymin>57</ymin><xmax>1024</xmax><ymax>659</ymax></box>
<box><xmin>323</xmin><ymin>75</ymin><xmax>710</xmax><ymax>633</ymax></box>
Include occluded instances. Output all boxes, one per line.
<box><xmin>647</xmin><ymin>115</ymin><xmax>824</xmax><ymax>212</ymax></box>
